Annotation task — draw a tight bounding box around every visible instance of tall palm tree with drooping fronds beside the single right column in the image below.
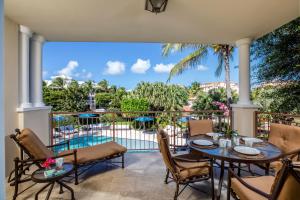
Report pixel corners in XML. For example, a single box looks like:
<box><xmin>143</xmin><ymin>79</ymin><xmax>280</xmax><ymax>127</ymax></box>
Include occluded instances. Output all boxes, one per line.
<box><xmin>162</xmin><ymin>43</ymin><xmax>234</xmax><ymax>104</ymax></box>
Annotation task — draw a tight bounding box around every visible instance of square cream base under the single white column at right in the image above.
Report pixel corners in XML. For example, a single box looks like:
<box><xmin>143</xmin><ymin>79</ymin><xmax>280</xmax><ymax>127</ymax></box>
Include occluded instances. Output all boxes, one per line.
<box><xmin>231</xmin><ymin>104</ymin><xmax>259</xmax><ymax>137</ymax></box>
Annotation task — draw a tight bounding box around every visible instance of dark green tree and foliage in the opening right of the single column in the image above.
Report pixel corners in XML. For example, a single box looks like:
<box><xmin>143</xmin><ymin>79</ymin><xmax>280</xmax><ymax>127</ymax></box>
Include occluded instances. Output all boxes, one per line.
<box><xmin>251</xmin><ymin>17</ymin><xmax>300</xmax><ymax>113</ymax></box>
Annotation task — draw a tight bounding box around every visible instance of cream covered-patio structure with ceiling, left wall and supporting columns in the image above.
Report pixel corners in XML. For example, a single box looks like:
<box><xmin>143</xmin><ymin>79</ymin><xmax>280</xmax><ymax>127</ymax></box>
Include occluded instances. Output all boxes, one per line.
<box><xmin>0</xmin><ymin>0</ymin><xmax>300</xmax><ymax>199</ymax></box>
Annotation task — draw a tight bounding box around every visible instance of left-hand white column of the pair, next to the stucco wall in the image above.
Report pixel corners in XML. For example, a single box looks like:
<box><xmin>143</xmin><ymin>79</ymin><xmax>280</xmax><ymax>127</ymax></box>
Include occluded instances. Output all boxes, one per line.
<box><xmin>19</xmin><ymin>25</ymin><xmax>32</xmax><ymax>108</ymax></box>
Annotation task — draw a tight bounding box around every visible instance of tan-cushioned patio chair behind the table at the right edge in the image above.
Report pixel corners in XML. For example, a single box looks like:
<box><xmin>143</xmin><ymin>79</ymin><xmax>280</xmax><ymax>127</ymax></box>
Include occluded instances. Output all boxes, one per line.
<box><xmin>258</xmin><ymin>123</ymin><xmax>300</xmax><ymax>174</ymax></box>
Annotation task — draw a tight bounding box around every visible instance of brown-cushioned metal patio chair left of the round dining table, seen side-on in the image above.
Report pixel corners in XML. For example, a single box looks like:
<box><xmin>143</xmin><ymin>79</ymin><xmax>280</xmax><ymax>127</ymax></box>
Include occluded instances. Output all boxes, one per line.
<box><xmin>157</xmin><ymin>129</ymin><xmax>214</xmax><ymax>200</ymax></box>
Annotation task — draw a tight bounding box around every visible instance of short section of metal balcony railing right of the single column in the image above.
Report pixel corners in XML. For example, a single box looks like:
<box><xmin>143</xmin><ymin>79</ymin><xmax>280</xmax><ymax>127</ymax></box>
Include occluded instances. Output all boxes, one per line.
<box><xmin>254</xmin><ymin>111</ymin><xmax>300</xmax><ymax>139</ymax></box>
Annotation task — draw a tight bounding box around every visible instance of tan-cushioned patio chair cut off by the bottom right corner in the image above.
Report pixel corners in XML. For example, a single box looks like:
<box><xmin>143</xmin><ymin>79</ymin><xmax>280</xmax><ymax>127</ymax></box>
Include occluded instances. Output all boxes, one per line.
<box><xmin>227</xmin><ymin>158</ymin><xmax>300</xmax><ymax>200</ymax></box>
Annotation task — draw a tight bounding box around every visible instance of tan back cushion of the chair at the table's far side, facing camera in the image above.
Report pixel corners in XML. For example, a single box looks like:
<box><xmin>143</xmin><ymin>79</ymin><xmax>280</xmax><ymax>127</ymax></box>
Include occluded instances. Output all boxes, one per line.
<box><xmin>188</xmin><ymin>120</ymin><xmax>213</xmax><ymax>137</ymax></box>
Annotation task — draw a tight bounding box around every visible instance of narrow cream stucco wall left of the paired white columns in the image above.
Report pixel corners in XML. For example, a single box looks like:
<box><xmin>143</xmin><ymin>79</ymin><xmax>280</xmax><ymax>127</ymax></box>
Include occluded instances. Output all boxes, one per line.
<box><xmin>4</xmin><ymin>18</ymin><xmax>19</xmax><ymax>174</ymax></box>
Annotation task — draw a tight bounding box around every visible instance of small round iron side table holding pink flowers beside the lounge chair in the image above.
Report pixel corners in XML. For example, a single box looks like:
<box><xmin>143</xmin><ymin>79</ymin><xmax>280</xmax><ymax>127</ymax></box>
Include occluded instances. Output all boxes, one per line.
<box><xmin>31</xmin><ymin>164</ymin><xmax>75</xmax><ymax>200</ymax></box>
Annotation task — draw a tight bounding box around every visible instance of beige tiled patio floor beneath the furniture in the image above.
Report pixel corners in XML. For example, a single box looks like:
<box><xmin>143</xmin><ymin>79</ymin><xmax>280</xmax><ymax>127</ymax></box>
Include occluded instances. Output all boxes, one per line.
<box><xmin>7</xmin><ymin>152</ymin><xmax>260</xmax><ymax>200</ymax></box>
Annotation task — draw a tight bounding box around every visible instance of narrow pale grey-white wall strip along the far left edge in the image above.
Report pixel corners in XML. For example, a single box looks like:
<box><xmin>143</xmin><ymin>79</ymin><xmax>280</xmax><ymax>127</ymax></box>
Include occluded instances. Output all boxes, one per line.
<box><xmin>0</xmin><ymin>0</ymin><xmax>5</xmax><ymax>200</ymax></box>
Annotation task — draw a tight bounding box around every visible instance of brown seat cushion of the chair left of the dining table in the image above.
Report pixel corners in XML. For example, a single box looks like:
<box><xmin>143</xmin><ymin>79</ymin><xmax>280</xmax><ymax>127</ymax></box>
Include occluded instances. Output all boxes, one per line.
<box><xmin>174</xmin><ymin>159</ymin><xmax>210</xmax><ymax>181</ymax></box>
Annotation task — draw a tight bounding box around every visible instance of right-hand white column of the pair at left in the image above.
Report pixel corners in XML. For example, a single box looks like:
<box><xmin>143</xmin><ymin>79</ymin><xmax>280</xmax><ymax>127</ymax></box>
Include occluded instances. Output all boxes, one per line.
<box><xmin>30</xmin><ymin>34</ymin><xmax>45</xmax><ymax>107</ymax></box>
